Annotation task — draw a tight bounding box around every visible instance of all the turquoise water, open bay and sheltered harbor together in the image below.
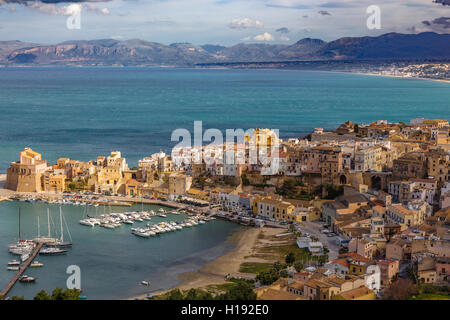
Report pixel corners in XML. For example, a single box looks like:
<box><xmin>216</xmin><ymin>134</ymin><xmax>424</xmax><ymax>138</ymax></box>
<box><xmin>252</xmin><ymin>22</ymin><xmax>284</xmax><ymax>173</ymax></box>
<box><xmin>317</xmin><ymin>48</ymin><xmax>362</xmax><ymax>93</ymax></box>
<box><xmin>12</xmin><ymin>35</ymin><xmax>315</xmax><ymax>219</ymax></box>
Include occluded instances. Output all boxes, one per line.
<box><xmin>0</xmin><ymin>67</ymin><xmax>450</xmax><ymax>299</ymax></box>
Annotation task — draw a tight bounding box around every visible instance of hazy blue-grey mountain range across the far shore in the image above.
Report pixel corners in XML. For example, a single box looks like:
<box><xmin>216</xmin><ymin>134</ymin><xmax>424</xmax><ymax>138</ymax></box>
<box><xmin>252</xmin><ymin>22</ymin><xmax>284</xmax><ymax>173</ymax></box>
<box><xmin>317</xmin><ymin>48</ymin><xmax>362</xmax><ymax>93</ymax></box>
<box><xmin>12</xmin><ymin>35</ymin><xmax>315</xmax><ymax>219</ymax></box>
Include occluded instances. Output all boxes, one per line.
<box><xmin>0</xmin><ymin>32</ymin><xmax>450</xmax><ymax>66</ymax></box>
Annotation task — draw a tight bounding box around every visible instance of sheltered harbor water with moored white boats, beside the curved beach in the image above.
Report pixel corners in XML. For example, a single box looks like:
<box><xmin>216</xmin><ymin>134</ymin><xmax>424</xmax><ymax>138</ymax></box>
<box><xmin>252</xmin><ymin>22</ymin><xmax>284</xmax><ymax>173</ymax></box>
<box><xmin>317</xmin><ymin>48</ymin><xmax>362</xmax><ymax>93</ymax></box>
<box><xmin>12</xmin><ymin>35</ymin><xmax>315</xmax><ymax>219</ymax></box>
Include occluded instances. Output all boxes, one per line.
<box><xmin>0</xmin><ymin>201</ymin><xmax>242</xmax><ymax>299</ymax></box>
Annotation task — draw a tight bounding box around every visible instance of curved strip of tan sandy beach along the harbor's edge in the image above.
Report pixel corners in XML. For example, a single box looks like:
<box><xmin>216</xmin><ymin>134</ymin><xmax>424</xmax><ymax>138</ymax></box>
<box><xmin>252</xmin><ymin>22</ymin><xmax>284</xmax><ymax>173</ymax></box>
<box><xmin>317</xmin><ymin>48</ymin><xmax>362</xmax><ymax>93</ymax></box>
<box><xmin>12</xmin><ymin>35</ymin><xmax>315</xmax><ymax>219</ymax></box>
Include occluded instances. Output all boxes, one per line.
<box><xmin>130</xmin><ymin>228</ymin><xmax>283</xmax><ymax>299</ymax></box>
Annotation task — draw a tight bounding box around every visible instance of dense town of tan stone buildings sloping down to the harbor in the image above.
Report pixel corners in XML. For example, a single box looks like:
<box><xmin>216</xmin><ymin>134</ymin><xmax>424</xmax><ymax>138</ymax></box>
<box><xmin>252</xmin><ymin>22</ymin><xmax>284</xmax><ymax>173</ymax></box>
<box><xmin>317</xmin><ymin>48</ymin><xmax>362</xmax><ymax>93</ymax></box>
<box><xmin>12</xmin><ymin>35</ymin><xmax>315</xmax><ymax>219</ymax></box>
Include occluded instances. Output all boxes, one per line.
<box><xmin>0</xmin><ymin>118</ymin><xmax>450</xmax><ymax>300</ymax></box>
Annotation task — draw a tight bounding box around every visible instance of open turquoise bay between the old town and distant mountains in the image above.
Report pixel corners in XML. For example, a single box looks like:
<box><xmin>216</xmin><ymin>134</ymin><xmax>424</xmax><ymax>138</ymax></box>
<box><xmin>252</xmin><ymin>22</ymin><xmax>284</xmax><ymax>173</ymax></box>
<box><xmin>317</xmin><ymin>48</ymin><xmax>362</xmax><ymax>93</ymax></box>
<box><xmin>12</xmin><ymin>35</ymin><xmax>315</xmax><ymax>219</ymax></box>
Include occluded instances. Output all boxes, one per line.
<box><xmin>0</xmin><ymin>68</ymin><xmax>450</xmax><ymax>172</ymax></box>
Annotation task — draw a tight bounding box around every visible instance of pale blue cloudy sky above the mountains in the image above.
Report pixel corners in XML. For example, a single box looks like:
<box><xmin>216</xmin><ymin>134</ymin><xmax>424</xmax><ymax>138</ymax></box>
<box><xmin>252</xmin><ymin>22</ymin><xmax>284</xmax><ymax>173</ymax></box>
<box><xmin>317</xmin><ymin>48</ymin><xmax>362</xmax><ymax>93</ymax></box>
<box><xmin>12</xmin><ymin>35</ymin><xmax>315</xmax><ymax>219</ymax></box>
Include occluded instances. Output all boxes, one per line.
<box><xmin>0</xmin><ymin>0</ymin><xmax>450</xmax><ymax>46</ymax></box>
